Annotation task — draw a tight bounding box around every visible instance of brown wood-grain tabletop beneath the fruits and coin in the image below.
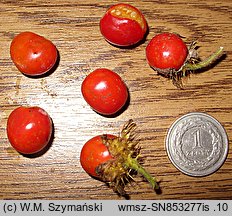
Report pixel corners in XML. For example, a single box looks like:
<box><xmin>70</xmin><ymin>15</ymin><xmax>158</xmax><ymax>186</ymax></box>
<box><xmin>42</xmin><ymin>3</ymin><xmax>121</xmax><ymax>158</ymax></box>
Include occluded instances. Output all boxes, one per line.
<box><xmin>0</xmin><ymin>0</ymin><xmax>232</xmax><ymax>199</ymax></box>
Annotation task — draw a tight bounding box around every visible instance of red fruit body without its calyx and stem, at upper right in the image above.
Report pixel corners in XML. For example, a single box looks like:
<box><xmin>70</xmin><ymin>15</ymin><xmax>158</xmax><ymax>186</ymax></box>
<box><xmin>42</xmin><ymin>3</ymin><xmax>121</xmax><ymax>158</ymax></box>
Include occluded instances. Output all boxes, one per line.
<box><xmin>146</xmin><ymin>33</ymin><xmax>188</xmax><ymax>71</ymax></box>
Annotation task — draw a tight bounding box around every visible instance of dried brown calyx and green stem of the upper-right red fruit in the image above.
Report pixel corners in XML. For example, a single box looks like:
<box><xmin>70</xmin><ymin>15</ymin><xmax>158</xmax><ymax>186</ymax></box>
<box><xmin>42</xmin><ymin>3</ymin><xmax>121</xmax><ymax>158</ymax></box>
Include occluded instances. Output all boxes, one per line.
<box><xmin>158</xmin><ymin>42</ymin><xmax>224</xmax><ymax>89</ymax></box>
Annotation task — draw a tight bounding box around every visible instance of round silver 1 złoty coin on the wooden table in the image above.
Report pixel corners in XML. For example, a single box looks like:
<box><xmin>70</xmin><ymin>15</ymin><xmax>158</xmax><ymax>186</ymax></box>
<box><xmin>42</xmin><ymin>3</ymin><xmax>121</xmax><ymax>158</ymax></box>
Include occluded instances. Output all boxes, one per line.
<box><xmin>166</xmin><ymin>112</ymin><xmax>229</xmax><ymax>176</ymax></box>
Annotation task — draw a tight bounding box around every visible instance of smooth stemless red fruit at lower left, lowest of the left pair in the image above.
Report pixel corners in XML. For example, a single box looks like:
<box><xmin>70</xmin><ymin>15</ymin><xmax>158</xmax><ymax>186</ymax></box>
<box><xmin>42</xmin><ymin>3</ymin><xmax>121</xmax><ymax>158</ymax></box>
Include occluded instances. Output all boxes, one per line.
<box><xmin>7</xmin><ymin>107</ymin><xmax>53</xmax><ymax>154</ymax></box>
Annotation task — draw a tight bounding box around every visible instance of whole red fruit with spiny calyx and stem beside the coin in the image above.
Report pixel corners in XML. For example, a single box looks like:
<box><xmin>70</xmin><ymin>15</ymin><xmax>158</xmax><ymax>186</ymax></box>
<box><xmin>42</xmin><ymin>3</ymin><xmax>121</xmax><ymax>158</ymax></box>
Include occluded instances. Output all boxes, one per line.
<box><xmin>80</xmin><ymin>120</ymin><xmax>159</xmax><ymax>196</ymax></box>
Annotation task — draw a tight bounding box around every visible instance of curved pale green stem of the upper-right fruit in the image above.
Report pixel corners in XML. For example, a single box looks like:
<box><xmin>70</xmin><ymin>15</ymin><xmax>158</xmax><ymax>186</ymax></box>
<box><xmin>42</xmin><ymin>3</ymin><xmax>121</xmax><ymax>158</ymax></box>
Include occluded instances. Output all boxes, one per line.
<box><xmin>184</xmin><ymin>47</ymin><xmax>223</xmax><ymax>71</ymax></box>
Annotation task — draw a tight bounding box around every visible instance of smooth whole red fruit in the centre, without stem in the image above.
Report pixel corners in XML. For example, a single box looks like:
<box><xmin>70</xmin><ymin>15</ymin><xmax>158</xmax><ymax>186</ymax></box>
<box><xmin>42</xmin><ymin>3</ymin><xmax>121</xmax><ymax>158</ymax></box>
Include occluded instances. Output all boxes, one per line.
<box><xmin>81</xmin><ymin>68</ymin><xmax>128</xmax><ymax>115</ymax></box>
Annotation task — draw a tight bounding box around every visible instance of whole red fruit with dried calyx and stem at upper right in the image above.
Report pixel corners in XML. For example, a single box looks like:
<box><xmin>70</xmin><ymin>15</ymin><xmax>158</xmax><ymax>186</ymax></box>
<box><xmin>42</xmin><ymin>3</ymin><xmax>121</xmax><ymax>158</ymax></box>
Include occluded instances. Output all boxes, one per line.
<box><xmin>146</xmin><ymin>32</ymin><xmax>223</xmax><ymax>88</ymax></box>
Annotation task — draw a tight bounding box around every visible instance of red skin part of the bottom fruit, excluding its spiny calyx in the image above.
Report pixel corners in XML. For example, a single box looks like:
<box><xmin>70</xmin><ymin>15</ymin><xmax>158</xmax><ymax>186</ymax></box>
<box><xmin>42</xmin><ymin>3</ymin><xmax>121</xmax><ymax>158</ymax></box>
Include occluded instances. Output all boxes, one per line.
<box><xmin>80</xmin><ymin>135</ymin><xmax>115</xmax><ymax>178</ymax></box>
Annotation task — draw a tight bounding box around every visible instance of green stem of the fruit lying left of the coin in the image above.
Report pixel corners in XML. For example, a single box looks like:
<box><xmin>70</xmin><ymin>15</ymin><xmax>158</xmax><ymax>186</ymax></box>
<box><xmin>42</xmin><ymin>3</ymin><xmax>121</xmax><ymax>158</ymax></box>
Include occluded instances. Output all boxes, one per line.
<box><xmin>126</xmin><ymin>157</ymin><xmax>159</xmax><ymax>189</ymax></box>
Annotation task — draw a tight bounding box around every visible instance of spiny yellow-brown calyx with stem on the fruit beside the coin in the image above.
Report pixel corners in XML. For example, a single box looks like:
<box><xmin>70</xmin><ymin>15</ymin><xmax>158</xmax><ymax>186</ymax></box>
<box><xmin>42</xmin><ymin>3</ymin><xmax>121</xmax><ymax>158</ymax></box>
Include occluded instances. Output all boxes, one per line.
<box><xmin>96</xmin><ymin>120</ymin><xmax>159</xmax><ymax>196</ymax></box>
